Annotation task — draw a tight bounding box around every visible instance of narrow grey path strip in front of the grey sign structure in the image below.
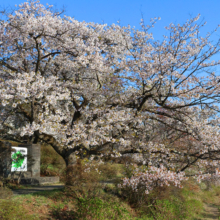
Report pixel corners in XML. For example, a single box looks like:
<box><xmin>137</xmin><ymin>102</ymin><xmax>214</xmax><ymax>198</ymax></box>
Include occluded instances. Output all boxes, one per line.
<box><xmin>12</xmin><ymin>185</ymin><xmax>64</xmax><ymax>195</ymax></box>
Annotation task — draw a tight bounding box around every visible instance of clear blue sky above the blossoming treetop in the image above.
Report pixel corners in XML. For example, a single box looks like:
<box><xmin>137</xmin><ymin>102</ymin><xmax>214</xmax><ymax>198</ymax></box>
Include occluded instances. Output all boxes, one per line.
<box><xmin>0</xmin><ymin>0</ymin><xmax>220</xmax><ymax>39</ymax></box>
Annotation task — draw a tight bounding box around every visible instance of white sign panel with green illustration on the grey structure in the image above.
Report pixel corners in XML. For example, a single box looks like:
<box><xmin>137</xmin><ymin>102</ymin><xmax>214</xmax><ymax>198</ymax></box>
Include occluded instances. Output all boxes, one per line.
<box><xmin>11</xmin><ymin>147</ymin><xmax>27</xmax><ymax>172</ymax></box>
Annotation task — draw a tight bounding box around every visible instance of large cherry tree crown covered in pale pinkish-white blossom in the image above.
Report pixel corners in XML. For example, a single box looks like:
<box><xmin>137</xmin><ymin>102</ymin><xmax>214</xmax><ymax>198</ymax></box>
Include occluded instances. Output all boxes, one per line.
<box><xmin>0</xmin><ymin>1</ymin><xmax>220</xmax><ymax>189</ymax></box>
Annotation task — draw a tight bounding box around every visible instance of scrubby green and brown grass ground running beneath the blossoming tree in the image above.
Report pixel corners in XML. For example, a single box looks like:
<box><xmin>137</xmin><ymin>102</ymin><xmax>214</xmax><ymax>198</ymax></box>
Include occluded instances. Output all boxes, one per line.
<box><xmin>0</xmin><ymin>174</ymin><xmax>220</xmax><ymax>220</ymax></box>
